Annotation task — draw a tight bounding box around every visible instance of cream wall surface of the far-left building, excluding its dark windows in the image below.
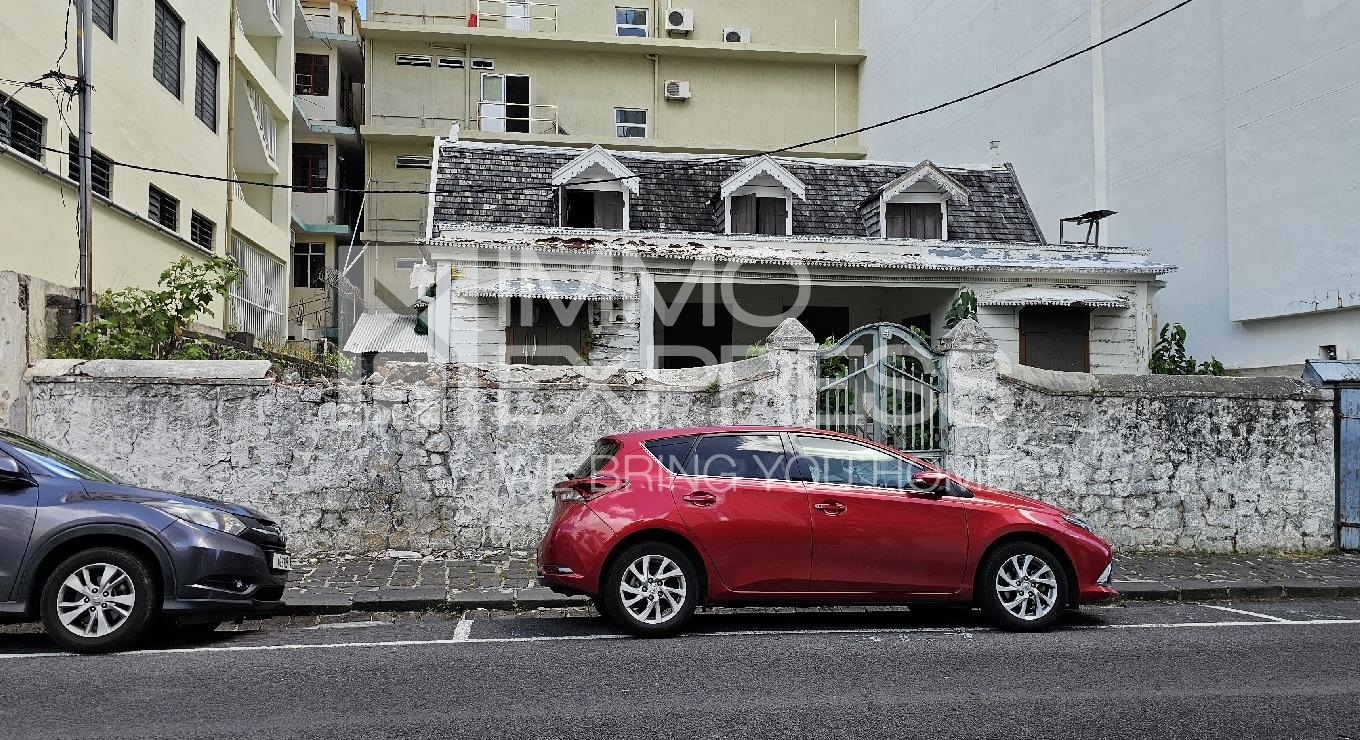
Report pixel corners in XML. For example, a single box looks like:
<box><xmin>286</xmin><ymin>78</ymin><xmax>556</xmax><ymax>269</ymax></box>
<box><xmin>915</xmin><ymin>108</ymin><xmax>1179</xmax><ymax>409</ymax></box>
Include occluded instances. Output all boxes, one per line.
<box><xmin>0</xmin><ymin>0</ymin><xmax>294</xmax><ymax>324</ymax></box>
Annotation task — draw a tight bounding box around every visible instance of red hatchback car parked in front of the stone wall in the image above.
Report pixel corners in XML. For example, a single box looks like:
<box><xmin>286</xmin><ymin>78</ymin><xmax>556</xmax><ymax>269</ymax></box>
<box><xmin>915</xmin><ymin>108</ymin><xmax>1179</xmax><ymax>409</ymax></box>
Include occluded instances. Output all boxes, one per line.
<box><xmin>539</xmin><ymin>427</ymin><xmax>1117</xmax><ymax>637</ymax></box>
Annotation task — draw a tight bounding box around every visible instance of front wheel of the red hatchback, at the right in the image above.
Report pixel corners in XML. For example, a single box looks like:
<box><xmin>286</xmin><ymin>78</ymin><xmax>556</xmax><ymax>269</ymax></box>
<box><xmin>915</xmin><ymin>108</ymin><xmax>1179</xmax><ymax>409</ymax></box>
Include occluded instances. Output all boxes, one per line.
<box><xmin>975</xmin><ymin>541</ymin><xmax>1068</xmax><ymax>633</ymax></box>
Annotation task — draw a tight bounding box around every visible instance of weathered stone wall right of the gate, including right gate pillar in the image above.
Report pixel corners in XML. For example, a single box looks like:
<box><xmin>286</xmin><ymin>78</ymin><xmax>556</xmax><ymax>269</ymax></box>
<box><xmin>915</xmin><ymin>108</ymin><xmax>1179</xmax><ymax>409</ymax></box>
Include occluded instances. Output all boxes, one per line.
<box><xmin>945</xmin><ymin>321</ymin><xmax>1336</xmax><ymax>552</ymax></box>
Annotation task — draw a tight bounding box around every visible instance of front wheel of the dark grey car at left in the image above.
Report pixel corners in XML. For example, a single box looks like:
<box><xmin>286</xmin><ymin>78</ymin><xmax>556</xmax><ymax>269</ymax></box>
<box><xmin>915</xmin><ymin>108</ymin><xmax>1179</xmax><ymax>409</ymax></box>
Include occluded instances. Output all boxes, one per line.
<box><xmin>41</xmin><ymin>547</ymin><xmax>160</xmax><ymax>653</ymax></box>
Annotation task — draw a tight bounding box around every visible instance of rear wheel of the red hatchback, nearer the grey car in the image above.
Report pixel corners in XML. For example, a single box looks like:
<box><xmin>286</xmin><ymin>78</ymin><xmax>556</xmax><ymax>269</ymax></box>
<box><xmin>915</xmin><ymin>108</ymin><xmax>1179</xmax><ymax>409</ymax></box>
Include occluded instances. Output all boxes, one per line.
<box><xmin>598</xmin><ymin>543</ymin><xmax>700</xmax><ymax>637</ymax></box>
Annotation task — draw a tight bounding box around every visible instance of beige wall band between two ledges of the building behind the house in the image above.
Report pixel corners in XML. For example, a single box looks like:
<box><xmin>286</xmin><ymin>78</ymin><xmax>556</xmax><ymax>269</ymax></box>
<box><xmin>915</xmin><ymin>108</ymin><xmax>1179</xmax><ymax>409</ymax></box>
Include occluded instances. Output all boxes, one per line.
<box><xmin>369</xmin><ymin>39</ymin><xmax>860</xmax><ymax>148</ymax></box>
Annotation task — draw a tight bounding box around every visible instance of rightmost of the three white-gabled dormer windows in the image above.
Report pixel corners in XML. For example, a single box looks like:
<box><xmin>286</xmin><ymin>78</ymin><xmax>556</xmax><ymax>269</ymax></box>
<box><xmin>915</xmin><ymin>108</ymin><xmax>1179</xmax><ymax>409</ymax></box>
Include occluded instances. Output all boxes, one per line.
<box><xmin>865</xmin><ymin>161</ymin><xmax>968</xmax><ymax>239</ymax></box>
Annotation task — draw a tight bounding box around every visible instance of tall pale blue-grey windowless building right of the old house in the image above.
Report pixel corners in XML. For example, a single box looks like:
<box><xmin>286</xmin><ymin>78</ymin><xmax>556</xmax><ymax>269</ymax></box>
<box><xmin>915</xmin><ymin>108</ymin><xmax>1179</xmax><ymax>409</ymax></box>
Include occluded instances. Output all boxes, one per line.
<box><xmin>862</xmin><ymin>0</ymin><xmax>1360</xmax><ymax>374</ymax></box>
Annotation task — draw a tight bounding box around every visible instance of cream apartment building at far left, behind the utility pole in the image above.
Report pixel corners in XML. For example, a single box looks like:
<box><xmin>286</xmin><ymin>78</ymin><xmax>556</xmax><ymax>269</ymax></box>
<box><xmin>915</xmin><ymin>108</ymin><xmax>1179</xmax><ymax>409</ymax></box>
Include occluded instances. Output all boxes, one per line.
<box><xmin>0</xmin><ymin>0</ymin><xmax>295</xmax><ymax>336</ymax></box>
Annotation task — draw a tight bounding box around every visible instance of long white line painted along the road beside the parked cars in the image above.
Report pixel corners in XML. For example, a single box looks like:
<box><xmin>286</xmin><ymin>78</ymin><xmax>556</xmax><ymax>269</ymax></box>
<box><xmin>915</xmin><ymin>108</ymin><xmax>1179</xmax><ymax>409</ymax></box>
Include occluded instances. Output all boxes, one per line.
<box><xmin>0</xmin><ymin>615</ymin><xmax>1360</xmax><ymax>660</ymax></box>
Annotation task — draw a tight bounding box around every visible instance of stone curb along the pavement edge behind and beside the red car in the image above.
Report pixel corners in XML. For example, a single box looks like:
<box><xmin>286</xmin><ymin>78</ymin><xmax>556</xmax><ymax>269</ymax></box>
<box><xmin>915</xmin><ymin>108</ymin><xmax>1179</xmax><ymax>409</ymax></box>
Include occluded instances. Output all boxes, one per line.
<box><xmin>275</xmin><ymin>579</ymin><xmax>1360</xmax><ymax>616</ymax></box>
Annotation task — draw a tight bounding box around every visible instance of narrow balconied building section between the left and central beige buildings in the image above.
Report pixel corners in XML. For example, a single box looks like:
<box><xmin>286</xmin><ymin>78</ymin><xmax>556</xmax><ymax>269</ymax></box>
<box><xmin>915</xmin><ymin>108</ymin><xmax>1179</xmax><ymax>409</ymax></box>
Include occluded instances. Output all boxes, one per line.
<box><xmin>288</xmin><ymin>0</ymin><xmax>363</xmax><ymax>343</ymax></box>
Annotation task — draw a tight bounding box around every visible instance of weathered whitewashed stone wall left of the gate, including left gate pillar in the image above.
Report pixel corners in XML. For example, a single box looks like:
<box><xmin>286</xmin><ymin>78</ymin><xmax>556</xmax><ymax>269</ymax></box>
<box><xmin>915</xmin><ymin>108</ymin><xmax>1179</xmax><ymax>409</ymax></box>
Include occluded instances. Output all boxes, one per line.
<box><xmin>29</xmin><ymin>321</ymin><xmax>816</xmax><ymax>552</ymax></box>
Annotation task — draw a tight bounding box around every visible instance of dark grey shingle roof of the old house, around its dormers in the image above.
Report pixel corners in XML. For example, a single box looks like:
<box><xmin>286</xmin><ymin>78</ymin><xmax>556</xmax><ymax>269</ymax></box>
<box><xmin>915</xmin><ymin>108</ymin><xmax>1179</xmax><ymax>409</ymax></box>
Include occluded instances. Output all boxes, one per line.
<box><xmin>434</xmin><ymin>141</ymin><xmax>1043</xmax><ymax>242</ymax></box>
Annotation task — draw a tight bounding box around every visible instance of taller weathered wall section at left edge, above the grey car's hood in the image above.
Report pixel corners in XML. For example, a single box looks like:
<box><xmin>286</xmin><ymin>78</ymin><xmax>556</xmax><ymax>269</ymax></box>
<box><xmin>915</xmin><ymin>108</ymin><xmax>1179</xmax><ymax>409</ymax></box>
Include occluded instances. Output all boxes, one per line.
<box><xmin>0</xmin><ymin>271</ymin><xmax>78</xmax><ymax>431</ymax></box>
